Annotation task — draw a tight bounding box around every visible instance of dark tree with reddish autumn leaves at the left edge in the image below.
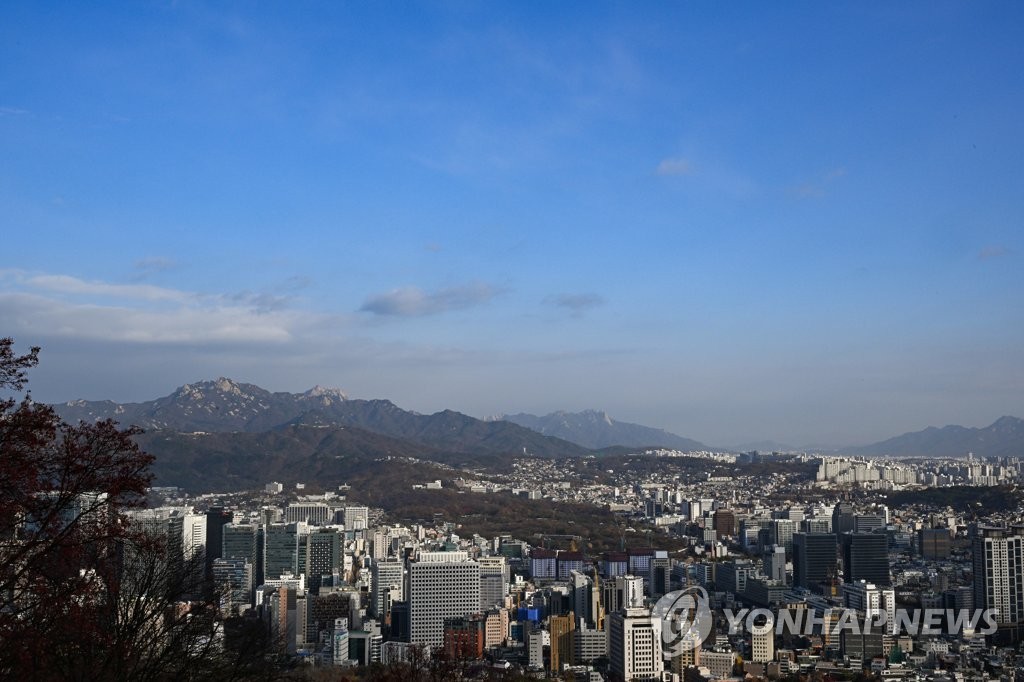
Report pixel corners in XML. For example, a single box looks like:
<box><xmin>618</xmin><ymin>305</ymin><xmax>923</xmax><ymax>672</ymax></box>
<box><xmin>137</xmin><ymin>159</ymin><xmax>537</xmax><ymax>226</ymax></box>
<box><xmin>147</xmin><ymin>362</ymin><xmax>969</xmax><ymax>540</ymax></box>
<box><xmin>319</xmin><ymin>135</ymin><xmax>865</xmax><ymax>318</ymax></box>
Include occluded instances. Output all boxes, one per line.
<box><xmin>0</xmin><ymin>338</ymin><xmax>153</xmax><ymax>676</ymax></box>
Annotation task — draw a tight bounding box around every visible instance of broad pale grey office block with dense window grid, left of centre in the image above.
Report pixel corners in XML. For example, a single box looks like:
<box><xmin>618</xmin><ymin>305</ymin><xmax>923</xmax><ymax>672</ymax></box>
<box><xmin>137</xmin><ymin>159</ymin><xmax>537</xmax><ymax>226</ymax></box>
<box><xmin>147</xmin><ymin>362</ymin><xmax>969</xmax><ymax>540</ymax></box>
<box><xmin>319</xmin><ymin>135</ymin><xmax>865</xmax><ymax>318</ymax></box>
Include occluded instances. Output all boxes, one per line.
<box><xmin>409</xmin><ymin>552</ymin><xmax>480</xmax><ymax>647</ymax></box>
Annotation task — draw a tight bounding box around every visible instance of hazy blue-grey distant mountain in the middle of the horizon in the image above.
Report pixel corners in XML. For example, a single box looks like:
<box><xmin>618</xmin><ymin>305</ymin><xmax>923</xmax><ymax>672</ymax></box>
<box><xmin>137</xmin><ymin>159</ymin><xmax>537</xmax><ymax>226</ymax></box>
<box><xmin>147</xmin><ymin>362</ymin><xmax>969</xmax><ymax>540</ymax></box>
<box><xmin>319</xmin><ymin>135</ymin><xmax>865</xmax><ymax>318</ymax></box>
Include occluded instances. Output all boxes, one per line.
<box><xmin>492</xmin><ymin>410</ymin><xmax>709</xmax><ymax>452</ymax></box>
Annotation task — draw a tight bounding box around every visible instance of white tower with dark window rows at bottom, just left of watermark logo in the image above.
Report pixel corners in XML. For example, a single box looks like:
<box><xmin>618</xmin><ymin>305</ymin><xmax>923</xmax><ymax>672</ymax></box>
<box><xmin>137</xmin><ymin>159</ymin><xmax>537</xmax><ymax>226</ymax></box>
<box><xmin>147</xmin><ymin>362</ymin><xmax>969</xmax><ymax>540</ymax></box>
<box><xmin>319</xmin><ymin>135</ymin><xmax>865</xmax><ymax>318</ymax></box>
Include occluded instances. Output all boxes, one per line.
<box><xmin>607</xmin><ymin>608</ymin><xmax>665</xmax><ymax>682</ymax></box>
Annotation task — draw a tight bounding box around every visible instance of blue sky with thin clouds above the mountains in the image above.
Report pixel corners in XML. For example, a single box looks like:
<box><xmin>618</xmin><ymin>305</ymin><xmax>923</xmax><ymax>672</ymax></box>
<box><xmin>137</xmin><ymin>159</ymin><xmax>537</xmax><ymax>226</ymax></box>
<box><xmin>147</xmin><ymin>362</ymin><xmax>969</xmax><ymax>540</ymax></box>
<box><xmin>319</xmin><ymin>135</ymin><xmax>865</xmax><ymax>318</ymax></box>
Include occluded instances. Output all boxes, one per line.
<box><xmin>0</xmin><ymin>2</ymin><xmax>1024</xmax><ymax>444</ymax></box>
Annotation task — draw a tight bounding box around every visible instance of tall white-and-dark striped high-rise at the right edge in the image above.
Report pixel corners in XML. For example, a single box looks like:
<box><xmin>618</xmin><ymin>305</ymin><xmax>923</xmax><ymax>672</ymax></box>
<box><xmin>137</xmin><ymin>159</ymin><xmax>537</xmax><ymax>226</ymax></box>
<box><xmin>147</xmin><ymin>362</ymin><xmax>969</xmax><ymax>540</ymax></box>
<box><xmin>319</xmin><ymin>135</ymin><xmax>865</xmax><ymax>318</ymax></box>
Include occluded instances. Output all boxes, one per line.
<box><xmin>971</xmin><ymin>526</ymin><xmax>1024</xmax><ymax>626</ymax></box>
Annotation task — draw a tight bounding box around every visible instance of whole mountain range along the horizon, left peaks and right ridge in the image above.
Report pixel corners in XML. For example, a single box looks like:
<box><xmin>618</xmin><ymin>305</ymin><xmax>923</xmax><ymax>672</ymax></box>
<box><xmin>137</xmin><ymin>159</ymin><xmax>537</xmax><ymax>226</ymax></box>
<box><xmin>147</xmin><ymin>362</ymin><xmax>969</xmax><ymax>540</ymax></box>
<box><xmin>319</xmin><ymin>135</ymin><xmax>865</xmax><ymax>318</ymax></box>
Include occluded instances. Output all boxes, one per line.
<box><xmin>54</xmin><ymin>378</ymin><xmax>1024</xmax><ymax>462</ymax></box>
